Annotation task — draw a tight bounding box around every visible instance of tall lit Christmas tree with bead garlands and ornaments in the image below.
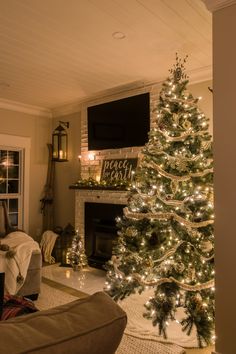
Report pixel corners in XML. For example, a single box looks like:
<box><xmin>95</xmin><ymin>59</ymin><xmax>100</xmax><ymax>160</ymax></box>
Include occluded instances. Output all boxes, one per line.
<box><xmin>106</xmin><ymin>56</ymin><xmax>215</xmax><ymax>347</ymax></box>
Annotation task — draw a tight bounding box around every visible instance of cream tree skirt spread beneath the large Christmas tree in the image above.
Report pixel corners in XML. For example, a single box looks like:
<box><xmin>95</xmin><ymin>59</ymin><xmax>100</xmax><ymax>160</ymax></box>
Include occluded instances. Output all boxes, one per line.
<box><xmin>119</xmin><ymin>290</ymin><xmax>202</xmax><ymax>354</ymax></box>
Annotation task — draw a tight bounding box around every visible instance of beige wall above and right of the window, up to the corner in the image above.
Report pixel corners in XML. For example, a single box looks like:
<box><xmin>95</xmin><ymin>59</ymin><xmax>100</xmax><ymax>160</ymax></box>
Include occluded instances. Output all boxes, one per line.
<box><xmin>0</xmin><ymin>109</ymin><xmax>52</xmax><ymax>239</ymax></box>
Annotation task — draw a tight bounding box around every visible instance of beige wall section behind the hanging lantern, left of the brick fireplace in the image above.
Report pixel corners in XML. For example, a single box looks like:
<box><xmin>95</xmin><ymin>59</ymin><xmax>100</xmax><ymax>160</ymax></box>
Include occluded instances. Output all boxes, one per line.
<box><xmin>53</xmin><ymin>112</ymin><xmax>81</xmax><ymax>227</ymax></box>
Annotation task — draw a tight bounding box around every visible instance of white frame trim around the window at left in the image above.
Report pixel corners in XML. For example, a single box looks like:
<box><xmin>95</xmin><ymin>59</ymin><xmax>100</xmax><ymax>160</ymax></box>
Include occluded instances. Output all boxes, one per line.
<box><xmin>0</xmin><ymin>134</ymin><xmax>31</xmax><ymax>233</ymax></box>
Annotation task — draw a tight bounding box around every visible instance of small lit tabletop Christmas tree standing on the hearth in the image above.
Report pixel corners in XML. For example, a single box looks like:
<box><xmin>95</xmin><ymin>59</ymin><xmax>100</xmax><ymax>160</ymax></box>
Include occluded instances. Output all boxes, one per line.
<box><xmin>68</xmin><ymin>230</ymin><xmax>87</xmax><ymax>270</ymax></box>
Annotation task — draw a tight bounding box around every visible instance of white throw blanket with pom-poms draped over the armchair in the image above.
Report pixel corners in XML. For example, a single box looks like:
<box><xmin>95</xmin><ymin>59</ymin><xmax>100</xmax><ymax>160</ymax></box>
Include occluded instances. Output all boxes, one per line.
<box><xmin>0</xmin><ymin>231</ymin><xmax>40</xmax><ymax>295</ymax></box>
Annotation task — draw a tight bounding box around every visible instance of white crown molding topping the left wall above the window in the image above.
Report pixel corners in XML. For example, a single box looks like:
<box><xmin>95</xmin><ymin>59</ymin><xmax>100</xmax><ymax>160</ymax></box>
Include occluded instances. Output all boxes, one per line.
<box><xmin>0</xmin><ymin>98</ymin><xmax>52</xmax><ymax>118</ymax></box>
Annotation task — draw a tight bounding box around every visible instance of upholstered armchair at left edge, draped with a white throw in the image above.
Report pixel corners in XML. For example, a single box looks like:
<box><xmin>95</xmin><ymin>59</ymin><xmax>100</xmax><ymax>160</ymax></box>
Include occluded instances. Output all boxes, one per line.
<box><xmin>0</xmin><ymin>201</ymin><xmax>42</xmax><ymax>300</ymax></box>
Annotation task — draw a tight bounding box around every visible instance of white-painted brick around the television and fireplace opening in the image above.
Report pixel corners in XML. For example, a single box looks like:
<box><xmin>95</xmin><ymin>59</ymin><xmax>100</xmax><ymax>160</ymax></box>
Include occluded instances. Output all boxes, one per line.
<box><xmin>73</xmin><ymin>84</ymin><xmax>160</xmax><ymax>262</ymax></box>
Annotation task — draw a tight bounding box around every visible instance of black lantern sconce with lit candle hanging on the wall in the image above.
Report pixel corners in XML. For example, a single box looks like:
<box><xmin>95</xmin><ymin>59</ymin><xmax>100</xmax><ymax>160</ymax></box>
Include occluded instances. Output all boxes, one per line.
<box><xmin>52</xmin><ymin>121</ymin><xmax>69</xmax><ymax>162</ymax></box>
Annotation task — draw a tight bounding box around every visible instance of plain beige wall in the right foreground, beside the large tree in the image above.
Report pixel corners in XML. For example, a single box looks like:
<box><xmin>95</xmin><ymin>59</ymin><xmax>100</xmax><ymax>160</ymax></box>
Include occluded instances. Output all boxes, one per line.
<box><xmin>213</xmin><ymin>5</ymin><xmax>236</xmax><ymax>354</ymax></box>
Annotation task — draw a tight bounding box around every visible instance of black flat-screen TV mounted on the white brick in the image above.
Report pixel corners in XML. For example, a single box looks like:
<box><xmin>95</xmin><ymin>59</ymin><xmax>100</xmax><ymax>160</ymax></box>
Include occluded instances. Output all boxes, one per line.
<box><xmin>87</xmin><ymin>93</ymin><xmax>150</xmax><ymax>150</ymax></box>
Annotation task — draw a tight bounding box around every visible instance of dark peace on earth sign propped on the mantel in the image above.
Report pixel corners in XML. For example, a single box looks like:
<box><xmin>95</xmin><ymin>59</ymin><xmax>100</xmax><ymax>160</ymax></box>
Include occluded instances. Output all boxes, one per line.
<box><xmin>101</xmin><ymin>158</ymin><xmax>138</xmax><ymax>182</ymax></box>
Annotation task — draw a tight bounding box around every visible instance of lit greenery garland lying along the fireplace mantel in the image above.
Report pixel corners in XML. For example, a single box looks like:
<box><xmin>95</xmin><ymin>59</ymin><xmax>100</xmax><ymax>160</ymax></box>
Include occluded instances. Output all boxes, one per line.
<box><xmin>69</xmin><ymin>177</ymin><xmax>131</xmax><ymax>191</ymax></box>
